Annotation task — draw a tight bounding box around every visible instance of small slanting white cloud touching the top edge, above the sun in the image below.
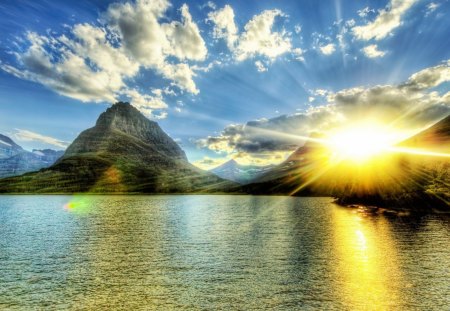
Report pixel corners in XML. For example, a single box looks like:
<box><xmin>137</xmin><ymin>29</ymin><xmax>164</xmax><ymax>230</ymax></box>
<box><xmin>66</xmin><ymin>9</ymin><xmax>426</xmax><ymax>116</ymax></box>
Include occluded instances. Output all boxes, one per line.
<box><xmin>352</xmin><ymin>0</ymin><xmax>418</xmax><ymax>41</ymax></box>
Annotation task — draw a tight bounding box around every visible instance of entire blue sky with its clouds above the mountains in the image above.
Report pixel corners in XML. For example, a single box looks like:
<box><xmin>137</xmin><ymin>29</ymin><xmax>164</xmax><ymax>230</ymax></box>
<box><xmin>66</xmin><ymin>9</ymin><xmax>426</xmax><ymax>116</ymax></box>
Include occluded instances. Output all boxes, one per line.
<box><xmin>0</xmin><ymin>0</ymin><xmax>450</xmax><ymax>168</ymax></box>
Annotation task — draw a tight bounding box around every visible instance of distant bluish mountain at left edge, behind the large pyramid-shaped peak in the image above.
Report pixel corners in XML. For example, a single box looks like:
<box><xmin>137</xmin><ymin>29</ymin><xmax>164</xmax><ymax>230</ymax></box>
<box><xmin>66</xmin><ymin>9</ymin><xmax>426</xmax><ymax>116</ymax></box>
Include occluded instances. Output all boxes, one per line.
<box><xmin>0</xmin><ymin>135</ymin><xmax>64</xmax><ymax>178</ymax></box>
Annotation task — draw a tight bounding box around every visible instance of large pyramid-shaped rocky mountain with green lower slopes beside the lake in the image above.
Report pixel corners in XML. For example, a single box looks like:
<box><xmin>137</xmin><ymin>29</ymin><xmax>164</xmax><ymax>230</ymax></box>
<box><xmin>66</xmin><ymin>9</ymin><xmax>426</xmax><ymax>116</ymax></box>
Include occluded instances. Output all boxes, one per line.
<box><xmin>0</xmin><ymin>102</ymin><xmax>237</xmax><ymax>193</ymax></box>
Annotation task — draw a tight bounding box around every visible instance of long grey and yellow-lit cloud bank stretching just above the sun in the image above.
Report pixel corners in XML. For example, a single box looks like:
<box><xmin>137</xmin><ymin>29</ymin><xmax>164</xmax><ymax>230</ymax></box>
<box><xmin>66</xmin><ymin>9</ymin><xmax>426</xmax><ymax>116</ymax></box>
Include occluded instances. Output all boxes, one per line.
<box><xmin>197</xmin><ymin>61</ymin><xmax>450</xmax><ymax>163</ymax></box>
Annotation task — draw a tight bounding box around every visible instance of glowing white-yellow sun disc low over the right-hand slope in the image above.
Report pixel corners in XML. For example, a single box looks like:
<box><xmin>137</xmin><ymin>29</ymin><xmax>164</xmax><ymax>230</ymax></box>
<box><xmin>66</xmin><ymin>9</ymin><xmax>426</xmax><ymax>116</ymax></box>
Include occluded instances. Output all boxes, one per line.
<box><xmin>327</xmin><ymin>123</ymin><xmax>398</xmax><ymax>163</ymax></box>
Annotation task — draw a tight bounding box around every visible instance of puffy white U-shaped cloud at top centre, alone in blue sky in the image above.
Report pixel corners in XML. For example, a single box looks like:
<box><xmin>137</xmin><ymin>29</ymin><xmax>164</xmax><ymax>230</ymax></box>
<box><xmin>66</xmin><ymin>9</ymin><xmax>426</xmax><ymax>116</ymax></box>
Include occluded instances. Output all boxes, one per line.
<box><xmin>208</xmin><ymin>5</ymin><xmax>292</xmax><ymax>61</ymax></box>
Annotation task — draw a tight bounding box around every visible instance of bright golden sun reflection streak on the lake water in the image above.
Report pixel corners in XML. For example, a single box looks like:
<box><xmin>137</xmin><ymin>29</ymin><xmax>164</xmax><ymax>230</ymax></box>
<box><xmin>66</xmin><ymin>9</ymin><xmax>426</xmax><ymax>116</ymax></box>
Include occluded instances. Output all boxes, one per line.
<box><xmin>332</xmin><ymin>208</ymin><xmax>402</xmax><ymax>310</ymax></box>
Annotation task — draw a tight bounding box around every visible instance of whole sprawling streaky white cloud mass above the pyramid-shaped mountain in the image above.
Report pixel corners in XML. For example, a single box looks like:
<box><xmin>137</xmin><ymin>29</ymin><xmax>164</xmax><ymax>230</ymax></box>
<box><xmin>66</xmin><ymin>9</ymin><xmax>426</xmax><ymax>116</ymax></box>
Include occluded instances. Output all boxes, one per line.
<box><xmin>0</xmin><ymin>0</ymin><xmax>208</xmax><ymax>116</ymax></box>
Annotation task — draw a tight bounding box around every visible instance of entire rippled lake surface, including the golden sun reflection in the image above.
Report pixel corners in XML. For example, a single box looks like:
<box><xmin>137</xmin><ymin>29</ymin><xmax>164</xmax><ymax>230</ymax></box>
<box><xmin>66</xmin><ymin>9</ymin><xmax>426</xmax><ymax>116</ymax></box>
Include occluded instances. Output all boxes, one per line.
<box><xmin>0</xmin><ymin>195</ymin><xmax>450</xmax><ymax>310</ymax></box>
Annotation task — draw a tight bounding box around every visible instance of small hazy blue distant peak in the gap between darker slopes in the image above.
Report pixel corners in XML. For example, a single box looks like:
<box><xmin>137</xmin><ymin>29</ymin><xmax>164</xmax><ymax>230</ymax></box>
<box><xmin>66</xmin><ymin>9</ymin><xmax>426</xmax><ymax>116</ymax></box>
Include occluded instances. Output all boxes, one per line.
<box><xmin>210</xmin><ymin>159</ymin><xmax>274</xmax><ymax>184</ymax></box>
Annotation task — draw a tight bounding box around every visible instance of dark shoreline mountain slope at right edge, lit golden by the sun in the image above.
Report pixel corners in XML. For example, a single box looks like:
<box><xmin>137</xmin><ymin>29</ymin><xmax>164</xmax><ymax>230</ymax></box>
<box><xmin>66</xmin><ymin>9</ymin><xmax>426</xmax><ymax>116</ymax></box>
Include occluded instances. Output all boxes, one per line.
<box><xmin>337</xmin><ymin>116</ymin><xmax>450</xmax><ymax>211</ymax></box>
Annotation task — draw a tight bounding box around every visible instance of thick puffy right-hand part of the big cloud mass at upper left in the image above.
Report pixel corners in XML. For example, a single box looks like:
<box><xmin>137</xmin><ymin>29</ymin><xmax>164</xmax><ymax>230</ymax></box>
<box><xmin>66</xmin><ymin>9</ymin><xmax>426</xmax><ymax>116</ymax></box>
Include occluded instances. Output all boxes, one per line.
<box><xmin>104</xmin><ymin>0</ymin><xmax>207</xmax><ymax>94</ymax></box>
